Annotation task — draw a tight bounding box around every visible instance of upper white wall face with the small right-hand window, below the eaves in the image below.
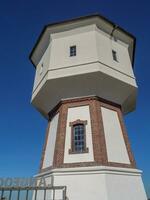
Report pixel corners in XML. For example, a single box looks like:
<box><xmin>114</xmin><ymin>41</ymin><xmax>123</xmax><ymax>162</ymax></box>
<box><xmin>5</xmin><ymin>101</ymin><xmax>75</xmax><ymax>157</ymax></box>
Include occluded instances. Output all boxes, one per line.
<box><xmin>95</xmin><ymin>28</ymin><xmax>134</xmax><ymax>78</ymax></box>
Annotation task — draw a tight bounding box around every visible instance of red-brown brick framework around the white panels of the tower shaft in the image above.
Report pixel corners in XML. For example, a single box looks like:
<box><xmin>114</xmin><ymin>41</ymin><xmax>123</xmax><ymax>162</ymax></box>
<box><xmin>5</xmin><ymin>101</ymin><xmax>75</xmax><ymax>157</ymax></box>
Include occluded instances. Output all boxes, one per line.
<box><xmin>40</xmin><ymin>97</ymin><xmax>136</xmax><ymax>172</ymax></box>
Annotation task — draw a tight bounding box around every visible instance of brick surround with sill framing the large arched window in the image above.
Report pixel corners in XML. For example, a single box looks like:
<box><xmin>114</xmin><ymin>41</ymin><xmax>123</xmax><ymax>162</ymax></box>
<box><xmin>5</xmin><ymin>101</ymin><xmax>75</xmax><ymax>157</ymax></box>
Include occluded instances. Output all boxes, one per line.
<box><xmin>69</xmin><ymin>119</ymin><xmax>89</xmax><ymax>154</ymax></box>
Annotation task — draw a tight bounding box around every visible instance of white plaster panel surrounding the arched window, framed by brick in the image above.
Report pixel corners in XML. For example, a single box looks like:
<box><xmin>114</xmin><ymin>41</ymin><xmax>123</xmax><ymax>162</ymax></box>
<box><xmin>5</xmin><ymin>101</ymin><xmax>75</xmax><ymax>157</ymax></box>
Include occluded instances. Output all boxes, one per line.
<box><xmin>64</xmin><ymin>106</ymin><xmax>94</xmax><ymax>163</ymax></box>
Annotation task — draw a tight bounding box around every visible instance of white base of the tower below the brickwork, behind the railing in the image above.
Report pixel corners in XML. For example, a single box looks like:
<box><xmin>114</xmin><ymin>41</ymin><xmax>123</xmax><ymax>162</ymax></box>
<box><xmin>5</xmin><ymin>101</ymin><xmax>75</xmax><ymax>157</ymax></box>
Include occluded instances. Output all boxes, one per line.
<box><xmin>37</xmin><ymin>166</ymin><xmax>147</xmax><ymax>200</ymax></box>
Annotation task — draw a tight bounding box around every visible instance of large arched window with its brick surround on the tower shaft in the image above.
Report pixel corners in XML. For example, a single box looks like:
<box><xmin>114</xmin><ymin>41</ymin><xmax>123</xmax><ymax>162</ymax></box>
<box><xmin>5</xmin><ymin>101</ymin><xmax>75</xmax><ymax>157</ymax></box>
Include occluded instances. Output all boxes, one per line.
<box><xmin>69</xmin><ymin>120</ymin><xmax>88</xmax><ymax>153</ymax></box>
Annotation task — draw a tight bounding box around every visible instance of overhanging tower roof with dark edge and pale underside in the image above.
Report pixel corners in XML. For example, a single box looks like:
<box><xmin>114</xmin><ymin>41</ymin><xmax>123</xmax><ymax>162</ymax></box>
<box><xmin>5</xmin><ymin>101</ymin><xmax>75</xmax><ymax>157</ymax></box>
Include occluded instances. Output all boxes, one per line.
<box><xmin>29</xmin><ymin>14</ymin><xmax>136</xmax><ymax>67</ymax></box>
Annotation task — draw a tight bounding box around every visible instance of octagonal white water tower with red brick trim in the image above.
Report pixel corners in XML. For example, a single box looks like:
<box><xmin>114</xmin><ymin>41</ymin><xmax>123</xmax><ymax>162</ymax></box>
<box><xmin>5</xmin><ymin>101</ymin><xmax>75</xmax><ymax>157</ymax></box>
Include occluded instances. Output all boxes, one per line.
<box><xmin>30</xmin><ymin>15</ymin><xmax>146</xmax><ymax>200</ymax></box>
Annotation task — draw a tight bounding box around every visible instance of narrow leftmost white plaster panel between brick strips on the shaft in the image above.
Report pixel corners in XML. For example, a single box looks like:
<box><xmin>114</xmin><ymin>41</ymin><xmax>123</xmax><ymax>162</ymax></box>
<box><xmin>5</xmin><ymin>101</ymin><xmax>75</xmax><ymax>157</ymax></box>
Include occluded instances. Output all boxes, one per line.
<box><xmin>43</xmin><ymin>114</ymin><xmax>59</xmax><ymax>168</ymax></box>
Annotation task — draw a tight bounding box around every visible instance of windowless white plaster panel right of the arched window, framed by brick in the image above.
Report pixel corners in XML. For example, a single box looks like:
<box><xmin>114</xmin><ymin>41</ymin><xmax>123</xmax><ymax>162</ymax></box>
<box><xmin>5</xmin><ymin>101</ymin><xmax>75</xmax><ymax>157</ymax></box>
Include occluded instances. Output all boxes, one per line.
<box><xmin>101</xmin><ymin>107</ymin><xmax>130</xmax><ymax>164</ymax></box>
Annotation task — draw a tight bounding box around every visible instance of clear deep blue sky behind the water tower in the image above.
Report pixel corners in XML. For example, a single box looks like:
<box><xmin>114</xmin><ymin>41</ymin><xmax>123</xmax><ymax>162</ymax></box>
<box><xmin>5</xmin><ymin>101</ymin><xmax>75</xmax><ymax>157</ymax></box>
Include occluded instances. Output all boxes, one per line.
<box><xmin>0</xmin><ymin>0</ymin><xmax>150</xmax><ymax>195</ymax></box>
